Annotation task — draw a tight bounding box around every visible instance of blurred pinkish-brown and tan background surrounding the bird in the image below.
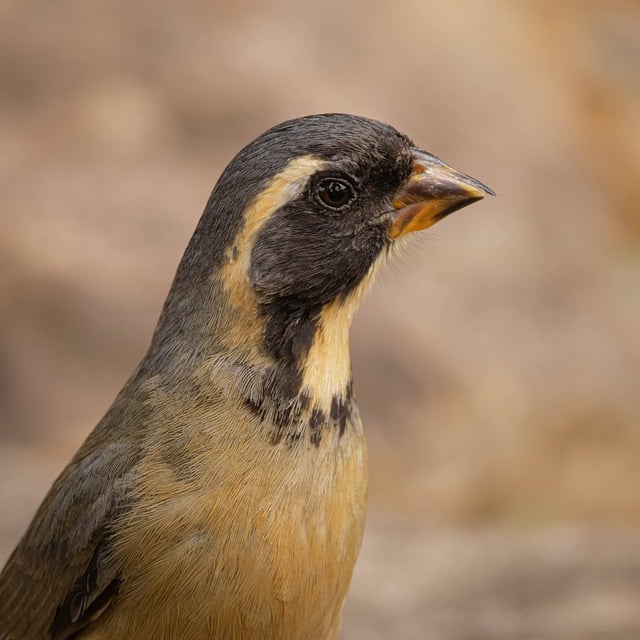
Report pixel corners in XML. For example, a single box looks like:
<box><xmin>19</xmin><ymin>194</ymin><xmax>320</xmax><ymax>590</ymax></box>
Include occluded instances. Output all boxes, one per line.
<box><xmin>0</xmin><ymin>0</ymin><xmax>640</xmax><ymax>640</ymax></box>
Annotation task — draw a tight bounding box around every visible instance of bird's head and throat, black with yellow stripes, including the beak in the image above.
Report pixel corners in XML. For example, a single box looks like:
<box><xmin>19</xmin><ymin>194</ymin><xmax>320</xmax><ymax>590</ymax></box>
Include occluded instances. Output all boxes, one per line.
<box><xmin>152</xmin><ymin>114</ymin><xmax>493</xmax><ymax>440</ymax></box>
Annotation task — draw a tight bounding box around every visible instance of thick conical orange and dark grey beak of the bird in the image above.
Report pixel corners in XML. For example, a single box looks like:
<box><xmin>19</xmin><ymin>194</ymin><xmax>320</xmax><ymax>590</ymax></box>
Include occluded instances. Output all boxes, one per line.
<box><xmin>389</xmin><ymin>149</ymin><xmax>496</xmax><ymax>238</ymax></box>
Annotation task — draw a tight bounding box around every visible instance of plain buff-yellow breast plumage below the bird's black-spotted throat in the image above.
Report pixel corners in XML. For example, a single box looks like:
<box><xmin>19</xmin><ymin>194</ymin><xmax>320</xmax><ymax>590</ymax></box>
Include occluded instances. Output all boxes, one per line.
<box><xmin>84</xmin><ymin>388</ymin><xmax>367</xmax><ymax>640</ymax></box>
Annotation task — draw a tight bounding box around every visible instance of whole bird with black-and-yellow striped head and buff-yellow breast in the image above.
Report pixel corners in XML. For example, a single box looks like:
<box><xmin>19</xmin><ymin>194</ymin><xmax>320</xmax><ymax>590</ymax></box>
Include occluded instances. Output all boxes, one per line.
<box><xmin>0</xmin><ymin>113</ymin><xmax>495</xmax><ymax>640</ymax></box>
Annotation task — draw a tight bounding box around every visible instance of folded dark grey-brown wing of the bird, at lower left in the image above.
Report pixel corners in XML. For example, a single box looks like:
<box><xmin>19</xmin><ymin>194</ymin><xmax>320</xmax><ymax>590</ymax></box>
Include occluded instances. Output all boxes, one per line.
<box><xmin>0</xmin><ymin>436</ymin><xmax>136</xmax><ymax>640</ymax></box>
